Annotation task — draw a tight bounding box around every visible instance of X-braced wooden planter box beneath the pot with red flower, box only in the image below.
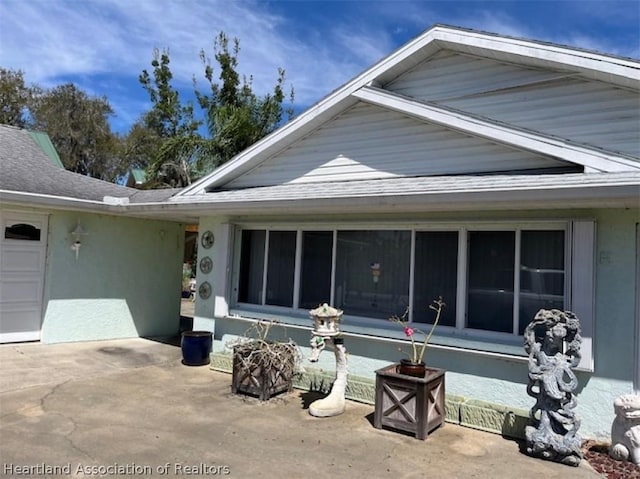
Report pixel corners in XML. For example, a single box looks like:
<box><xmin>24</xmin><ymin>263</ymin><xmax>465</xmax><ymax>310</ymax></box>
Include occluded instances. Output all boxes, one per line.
<box><xmin>373</xmin><ymin>363</ymin><xmax>445</xmax><ymax>439</ymax></box>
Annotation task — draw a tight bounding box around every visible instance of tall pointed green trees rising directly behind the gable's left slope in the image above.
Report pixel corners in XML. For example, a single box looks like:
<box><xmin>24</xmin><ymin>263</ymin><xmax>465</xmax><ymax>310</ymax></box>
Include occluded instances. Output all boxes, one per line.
<box><xmin>134</xmin><ymin>33</ymin><xmax>293</xmax><ymax>188</ymax></box>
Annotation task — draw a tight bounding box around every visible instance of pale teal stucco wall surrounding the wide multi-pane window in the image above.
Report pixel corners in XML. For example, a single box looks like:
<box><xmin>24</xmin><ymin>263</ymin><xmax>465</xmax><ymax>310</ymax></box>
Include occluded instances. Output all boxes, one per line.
<box><xmin>196</xmin><ymin>208</ymin><xmax>640</xmax><ymax>438</ymax></box>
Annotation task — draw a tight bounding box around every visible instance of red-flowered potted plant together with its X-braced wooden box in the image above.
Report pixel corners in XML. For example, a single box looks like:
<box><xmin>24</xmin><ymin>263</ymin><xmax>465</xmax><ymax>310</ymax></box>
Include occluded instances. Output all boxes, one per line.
<box><xmin>374</xmin><ymin>297</ymin><xmax>445</xmax><ymax>439</ymax></box>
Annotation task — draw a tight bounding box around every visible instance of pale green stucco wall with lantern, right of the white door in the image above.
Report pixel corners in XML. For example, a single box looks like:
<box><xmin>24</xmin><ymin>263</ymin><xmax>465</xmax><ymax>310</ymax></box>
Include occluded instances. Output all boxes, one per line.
<box><xmin>41</xmin><ymin>212</ymin><xmax>184</xmax><ymax>343</ymax></box>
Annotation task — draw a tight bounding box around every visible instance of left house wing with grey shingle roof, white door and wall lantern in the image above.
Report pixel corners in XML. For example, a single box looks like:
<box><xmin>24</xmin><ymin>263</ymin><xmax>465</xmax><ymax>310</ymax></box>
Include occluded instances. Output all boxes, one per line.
<box><xmin>0</xmin><ymin>125</ymin><xmax>189</xmax><ymax>343</ymax></box>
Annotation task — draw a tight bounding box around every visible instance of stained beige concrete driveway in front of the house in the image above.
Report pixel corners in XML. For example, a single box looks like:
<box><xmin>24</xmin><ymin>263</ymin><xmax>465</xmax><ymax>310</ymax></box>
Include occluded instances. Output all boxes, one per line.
<box><xmin>0</xmin><ymin>339</ymin><xmax>599</xmax><ymax>479</ymax></box>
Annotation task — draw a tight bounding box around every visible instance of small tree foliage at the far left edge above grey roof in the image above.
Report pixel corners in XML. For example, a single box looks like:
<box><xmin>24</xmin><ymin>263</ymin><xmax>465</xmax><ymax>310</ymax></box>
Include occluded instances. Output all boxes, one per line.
<box><xmin>0</xmin><ymin>67</ymin><xmax>35</xmax><ymax>128</ymax></box>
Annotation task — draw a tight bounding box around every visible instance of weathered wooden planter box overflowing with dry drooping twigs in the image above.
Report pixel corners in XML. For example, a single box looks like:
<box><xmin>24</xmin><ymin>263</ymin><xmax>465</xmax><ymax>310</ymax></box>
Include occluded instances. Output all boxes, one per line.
<box><xmin>231</xmin><ymin>343</ymin><xmax>297</xmax><ymax>401</ymax></box>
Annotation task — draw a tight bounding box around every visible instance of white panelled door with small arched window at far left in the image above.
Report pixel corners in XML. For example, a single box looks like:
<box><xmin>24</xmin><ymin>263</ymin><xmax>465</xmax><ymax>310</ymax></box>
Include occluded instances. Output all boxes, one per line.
<box><xmin>0</xmin><ymin>212</ymin><xmax>47</xmax><ymax>343</ymax></box>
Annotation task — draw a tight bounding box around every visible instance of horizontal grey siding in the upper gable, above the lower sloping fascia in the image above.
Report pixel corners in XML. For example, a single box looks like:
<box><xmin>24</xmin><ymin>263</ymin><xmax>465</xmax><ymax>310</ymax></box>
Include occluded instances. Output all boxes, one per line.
<box><xmin>385</xmin><ymin>51</ymin><xmax>640</xmax><ymax>161</ymax></box>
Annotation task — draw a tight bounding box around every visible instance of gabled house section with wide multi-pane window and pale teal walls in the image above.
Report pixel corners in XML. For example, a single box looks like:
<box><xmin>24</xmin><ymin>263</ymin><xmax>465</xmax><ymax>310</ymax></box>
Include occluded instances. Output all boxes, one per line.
<box><xmin>170</xmin><ymin>26</ymin><xmax>640</xmax><ymax>436</ymax></box>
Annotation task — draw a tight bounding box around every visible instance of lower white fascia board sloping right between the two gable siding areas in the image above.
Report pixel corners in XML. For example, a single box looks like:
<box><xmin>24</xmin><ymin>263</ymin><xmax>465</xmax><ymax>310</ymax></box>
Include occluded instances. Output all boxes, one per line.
<box><xmin>353</xmin><ymin>87</ymin><xmax>640</xmax><ymax>173</ymax></box>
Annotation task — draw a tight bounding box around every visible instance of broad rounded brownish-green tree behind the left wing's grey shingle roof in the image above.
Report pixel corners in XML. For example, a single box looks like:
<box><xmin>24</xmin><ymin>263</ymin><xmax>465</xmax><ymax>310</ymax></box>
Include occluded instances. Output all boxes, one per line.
<box><xmin>28</xmin><ymin>83</ymin><xmax>123</xmax><ymax>181</ymax></box>
